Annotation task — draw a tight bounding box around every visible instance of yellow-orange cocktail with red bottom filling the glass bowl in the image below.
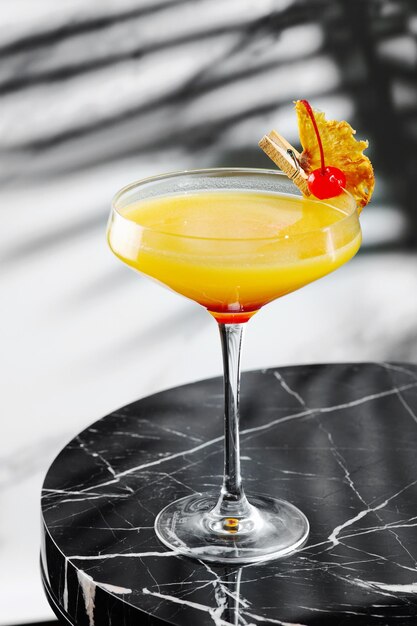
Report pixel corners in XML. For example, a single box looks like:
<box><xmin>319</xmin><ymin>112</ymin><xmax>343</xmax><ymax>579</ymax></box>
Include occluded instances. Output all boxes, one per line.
<box><xmin>109</xmin><ymin>191</ymin><xmax>361</xmax><ymax>322</ymax></box>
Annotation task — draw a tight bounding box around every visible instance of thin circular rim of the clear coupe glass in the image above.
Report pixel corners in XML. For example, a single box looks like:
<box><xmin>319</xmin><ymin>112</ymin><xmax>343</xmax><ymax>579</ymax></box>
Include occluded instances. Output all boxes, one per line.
<box><xmin>111</xmin><ymin>167</ymin><xmax>359</xmax><ymax>242</ymax></box>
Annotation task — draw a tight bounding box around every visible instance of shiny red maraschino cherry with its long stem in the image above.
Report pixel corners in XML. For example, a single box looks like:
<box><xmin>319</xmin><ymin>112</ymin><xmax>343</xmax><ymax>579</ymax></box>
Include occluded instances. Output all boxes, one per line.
<box><xmin>301</xmin><ymin>100</ymin><xmax>346</xmax><ymax>200</ymax></box>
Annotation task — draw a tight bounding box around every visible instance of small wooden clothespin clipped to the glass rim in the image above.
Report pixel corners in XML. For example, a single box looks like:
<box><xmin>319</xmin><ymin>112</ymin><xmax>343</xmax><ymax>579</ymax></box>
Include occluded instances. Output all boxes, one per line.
<box><xmin>259</xmin><ymin>130</ymin><xmax>311</xmax><ymax>196</ymax></box>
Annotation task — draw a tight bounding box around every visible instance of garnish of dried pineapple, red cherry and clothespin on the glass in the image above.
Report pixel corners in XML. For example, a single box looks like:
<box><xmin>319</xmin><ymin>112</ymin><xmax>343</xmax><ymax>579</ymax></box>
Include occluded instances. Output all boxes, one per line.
<box><xmin>259</xmin><ymin>100</ymin><xmax>375</xmax><ymax>211</ymax></box>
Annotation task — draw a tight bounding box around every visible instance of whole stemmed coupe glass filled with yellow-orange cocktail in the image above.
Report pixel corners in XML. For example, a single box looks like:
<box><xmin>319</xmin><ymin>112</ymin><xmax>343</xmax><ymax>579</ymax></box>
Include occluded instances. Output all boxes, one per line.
<box><xmin>108</xmin><ymin>168</ymin><xmax>361</xmax><ymax>564</ymax></box>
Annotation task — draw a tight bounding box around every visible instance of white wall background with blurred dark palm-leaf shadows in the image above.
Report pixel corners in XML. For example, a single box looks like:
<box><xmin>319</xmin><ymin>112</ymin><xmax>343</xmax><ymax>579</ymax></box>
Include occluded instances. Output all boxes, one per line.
<box><xmin>0</xmin><ymin>0</ymin><xmax>417</xmax><ymax>626</ymax></box>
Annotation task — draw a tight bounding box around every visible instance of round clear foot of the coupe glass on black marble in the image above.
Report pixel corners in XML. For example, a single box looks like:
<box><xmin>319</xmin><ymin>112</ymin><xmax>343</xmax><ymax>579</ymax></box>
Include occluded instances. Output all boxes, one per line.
<box><xmin>155</xmin><ymin>494</ymin><xmax>310</xmax><ymax>564</ymax></box>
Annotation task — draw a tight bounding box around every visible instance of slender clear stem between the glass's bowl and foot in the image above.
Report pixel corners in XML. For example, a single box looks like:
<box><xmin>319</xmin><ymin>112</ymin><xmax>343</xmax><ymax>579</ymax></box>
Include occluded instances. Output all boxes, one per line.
<box><xmin>213</xmin><ymin>324</ymin><xmax>252</xmax><ymax>518</ymax></box>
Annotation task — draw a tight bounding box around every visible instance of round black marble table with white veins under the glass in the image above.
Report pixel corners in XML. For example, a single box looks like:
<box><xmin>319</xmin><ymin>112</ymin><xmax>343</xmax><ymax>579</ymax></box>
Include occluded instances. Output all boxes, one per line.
<box><xmin>41</xmin><ymin>363</ymin><xmax>417</xmax><ymax>626</ymax></box>
